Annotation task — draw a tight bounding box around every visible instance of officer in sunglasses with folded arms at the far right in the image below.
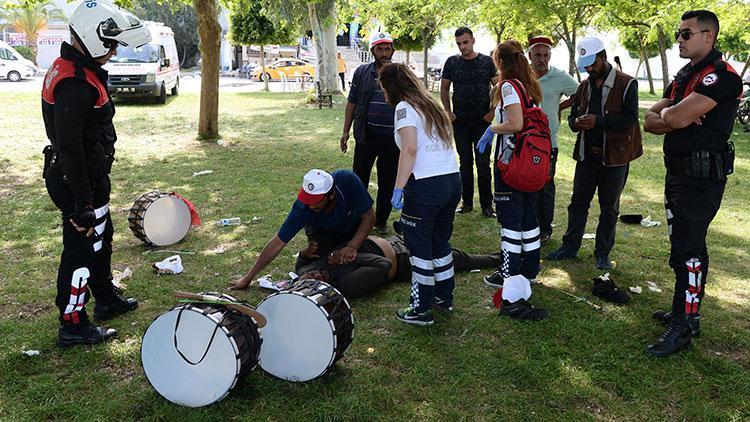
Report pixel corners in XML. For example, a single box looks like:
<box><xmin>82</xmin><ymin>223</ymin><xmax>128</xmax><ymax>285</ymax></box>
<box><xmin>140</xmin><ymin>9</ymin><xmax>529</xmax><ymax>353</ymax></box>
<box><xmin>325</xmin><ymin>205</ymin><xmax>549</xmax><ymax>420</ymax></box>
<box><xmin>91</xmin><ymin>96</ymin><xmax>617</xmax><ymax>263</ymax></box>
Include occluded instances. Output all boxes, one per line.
<box><xmin>644</xmin><ymin>10</ymin><xmax>742</xmax><ymax>356</ymax></box>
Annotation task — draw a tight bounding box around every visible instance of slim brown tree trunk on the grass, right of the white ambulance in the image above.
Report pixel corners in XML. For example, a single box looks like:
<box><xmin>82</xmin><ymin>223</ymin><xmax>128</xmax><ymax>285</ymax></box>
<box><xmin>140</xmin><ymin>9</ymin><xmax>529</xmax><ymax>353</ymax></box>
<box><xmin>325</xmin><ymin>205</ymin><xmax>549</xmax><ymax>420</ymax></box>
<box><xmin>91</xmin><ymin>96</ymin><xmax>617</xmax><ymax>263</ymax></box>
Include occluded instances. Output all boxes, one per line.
<box><xmin>193</xmin><ymin>0</ymin><xmax>221</xmax><ymax>139</ymax></box>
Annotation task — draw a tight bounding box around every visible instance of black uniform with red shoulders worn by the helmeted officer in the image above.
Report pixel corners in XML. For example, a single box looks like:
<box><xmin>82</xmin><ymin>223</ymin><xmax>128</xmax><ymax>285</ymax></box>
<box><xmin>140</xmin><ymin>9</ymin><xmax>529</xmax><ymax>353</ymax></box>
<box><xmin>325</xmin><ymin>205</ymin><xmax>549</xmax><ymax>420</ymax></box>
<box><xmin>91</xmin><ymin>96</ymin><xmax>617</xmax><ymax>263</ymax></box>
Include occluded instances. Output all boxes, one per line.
<box><xmin>42</xmin><ymin>43</ymin><xmax>132</xmax><ymax>332</ymax></box>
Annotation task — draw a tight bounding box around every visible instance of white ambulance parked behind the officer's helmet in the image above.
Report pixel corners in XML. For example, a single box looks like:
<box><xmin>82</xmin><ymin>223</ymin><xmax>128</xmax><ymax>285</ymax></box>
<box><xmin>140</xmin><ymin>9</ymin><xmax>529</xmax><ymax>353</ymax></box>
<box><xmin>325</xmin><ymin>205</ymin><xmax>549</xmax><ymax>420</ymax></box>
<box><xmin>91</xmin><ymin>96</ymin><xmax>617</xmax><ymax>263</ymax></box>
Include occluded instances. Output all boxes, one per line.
<box><xmin>104</xmin><ymin>21</ymin><xmax>180</xmax><ymax>104</ymax></box>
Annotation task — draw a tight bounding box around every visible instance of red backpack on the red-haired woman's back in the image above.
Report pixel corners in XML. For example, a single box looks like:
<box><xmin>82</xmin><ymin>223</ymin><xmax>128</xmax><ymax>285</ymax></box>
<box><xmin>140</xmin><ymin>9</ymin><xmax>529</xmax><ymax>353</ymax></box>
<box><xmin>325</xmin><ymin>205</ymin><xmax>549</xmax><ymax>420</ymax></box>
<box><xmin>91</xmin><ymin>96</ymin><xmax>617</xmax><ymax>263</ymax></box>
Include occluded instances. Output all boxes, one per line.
<box><xmin>497</xmin><ymin>79</ymin><xmax>552</xmax><ymax>192</ymax></box>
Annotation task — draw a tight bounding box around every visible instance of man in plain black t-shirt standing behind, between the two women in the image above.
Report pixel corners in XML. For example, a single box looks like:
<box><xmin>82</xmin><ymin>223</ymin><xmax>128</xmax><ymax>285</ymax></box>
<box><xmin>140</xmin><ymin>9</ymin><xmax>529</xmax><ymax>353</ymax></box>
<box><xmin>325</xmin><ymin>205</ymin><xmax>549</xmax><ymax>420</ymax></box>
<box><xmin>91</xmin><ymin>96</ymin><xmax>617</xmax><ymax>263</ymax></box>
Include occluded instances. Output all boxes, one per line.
<box><xmin>440</xmin><ymin>27</ymin><xmax>498</xmax><ymax>217</ymax></box>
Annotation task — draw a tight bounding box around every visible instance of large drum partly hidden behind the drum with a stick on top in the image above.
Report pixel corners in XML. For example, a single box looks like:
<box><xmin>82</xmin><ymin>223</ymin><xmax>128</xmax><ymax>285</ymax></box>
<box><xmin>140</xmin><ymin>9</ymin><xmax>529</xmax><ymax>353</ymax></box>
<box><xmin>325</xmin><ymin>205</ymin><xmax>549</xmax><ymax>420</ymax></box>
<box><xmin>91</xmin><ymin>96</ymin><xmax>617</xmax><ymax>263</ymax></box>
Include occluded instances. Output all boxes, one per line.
<box><xmin>257</xmin><ymin>280</ymin><xmax>354</xmax><ymax>382</ymax></box>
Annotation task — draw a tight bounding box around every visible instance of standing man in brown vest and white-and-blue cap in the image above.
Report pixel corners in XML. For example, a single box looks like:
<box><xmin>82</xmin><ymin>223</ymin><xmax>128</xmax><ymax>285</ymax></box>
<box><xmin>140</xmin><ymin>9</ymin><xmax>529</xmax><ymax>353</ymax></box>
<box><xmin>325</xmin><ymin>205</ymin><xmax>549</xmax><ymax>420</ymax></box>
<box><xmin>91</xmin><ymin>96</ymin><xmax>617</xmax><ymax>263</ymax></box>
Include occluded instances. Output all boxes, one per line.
<box><xmin>547</xmin><ymin>37</ymin><xmax>643</xmax><ymax>294</ymax></box>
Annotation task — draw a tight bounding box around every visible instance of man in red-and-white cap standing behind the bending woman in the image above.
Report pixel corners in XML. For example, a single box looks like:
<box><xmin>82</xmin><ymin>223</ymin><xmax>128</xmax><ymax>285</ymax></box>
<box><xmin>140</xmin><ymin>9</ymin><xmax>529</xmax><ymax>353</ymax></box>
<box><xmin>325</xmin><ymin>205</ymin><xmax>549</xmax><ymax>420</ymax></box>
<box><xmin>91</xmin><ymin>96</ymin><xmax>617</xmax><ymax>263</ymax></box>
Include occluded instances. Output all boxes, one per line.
<box><xmin>339</xmin><ymin>31</ymin><xmax>399</xmax><ymax>235</ymax></box>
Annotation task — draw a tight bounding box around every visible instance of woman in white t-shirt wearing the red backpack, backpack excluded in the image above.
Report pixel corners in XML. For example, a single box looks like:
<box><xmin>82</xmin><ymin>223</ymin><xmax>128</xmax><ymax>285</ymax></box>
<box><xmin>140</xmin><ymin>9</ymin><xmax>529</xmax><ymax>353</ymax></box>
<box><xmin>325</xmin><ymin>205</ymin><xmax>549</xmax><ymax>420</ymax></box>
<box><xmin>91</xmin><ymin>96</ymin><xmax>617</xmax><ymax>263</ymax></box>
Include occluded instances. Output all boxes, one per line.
<box><xmin>484</xmin><ymin>40</ymin><xmax>547</xmax><ymax>320</ymax></box>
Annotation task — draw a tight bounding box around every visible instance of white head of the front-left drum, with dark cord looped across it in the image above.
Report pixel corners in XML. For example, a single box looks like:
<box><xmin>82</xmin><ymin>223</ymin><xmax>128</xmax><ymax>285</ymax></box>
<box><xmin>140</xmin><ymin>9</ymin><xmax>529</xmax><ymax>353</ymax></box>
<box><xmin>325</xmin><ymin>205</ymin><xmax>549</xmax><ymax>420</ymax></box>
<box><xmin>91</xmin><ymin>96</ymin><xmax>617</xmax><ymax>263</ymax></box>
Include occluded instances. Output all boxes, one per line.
<box><xmin>141</xmin><ymin>309</ymin><xmax>240</xmax><ymax>407</ymax></box>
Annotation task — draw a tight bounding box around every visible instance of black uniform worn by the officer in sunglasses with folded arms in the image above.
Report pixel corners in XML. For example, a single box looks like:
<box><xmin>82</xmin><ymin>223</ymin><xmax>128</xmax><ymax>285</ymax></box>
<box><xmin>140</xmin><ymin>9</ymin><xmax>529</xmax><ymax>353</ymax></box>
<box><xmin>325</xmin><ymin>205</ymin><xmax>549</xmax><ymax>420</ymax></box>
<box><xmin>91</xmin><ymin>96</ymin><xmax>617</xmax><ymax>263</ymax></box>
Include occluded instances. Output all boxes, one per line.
<box><xmin>664</xmin><ymin>50</ymin><xmax>742</xmax><ymax>333</ymax></box>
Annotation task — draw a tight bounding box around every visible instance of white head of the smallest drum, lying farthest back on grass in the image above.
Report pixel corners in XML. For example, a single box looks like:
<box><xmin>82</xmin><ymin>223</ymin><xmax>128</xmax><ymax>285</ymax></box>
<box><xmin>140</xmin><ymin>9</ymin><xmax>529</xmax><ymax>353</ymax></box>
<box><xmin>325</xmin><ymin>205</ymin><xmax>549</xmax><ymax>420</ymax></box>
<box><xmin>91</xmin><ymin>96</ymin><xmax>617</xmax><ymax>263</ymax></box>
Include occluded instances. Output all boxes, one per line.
<box><xmin>143</xmin><ymin>195</ymin><xmax>191</xmax><ymax>246</ymax></box>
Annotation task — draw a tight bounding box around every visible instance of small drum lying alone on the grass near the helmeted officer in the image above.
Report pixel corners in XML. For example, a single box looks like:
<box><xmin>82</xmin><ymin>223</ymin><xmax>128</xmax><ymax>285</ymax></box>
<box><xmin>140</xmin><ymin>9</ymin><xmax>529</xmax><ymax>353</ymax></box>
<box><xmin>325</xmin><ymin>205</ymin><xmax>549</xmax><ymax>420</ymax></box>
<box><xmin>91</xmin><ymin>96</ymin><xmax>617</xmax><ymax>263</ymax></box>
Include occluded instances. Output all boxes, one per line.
<box><xmin>128</xmin><ymin>191</ymin><xmax>191</xmax><ymax>246</ymax></box>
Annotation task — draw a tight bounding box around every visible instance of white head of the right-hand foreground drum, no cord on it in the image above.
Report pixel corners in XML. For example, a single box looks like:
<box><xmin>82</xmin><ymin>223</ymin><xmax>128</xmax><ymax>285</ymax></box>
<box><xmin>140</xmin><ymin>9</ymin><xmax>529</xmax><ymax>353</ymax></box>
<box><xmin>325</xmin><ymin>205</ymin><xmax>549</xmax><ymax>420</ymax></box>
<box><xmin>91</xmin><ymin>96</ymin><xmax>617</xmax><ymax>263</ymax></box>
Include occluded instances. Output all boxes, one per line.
<box><xmin>258</xmin><ymin>293</ymin><xmax>335</xmax><ymax>382</ymax></box>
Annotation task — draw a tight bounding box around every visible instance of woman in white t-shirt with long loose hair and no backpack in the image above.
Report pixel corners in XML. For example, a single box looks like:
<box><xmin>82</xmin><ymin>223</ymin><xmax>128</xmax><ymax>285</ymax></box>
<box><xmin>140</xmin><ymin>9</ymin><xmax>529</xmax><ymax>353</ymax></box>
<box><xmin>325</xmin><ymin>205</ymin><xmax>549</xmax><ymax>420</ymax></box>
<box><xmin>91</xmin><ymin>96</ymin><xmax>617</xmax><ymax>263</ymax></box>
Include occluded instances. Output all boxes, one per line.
<box><xmin>379</xmin><ymin>63</ymin><xmax>461</xmax><ymax>325</ymax></box>
